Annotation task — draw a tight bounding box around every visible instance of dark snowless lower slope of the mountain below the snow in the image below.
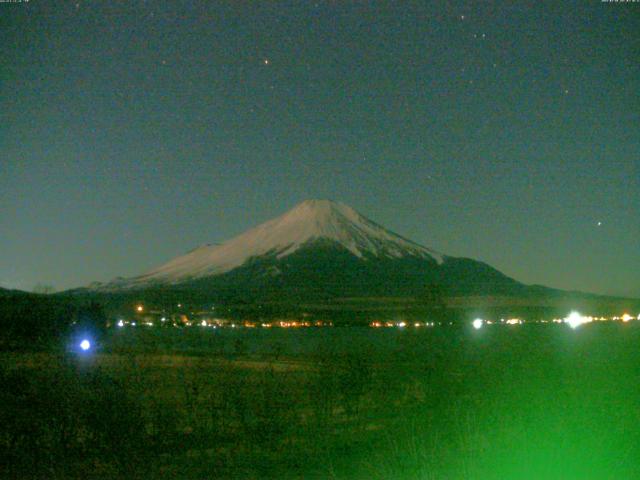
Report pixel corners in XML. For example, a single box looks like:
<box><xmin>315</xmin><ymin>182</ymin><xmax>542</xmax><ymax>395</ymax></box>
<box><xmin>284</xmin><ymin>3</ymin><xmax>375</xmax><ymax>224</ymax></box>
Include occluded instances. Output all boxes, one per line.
<box><xmin>176</xmin><ymin>239</ymin><xmax>525</xmax><ymax>299</ymax></box>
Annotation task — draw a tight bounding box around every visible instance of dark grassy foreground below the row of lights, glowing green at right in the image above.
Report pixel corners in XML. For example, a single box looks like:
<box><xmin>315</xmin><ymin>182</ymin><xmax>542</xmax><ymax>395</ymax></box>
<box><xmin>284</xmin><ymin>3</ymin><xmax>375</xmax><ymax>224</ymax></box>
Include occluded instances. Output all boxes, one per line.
<box><xmin>0</xmin><ymin>322</ymin><xmax>640</xmax><ymax>480</ymax></box>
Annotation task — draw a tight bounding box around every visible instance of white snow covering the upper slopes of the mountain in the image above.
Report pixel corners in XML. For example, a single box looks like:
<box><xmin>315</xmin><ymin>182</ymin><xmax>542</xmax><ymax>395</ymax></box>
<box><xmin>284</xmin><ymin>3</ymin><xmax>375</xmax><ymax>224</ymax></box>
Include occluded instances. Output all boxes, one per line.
<box><xmin>111</xmin><ymin>200</ymin><xmax>443</xmax><ymax>287</ymax></box>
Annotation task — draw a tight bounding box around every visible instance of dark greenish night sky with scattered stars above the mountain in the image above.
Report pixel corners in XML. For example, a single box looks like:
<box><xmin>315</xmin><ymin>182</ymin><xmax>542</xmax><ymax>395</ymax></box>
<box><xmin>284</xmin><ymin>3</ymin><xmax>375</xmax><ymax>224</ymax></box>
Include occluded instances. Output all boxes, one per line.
<box><xmin>0</xmin><ymin>0</ymin><xmax>640</xmax><ymax>297</ymax></box>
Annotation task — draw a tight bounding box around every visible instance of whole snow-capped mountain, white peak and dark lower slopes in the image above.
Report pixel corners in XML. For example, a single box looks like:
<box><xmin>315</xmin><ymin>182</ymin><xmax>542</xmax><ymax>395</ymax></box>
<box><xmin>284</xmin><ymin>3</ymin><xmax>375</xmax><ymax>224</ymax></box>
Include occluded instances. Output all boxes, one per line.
<box><xmin>88</xmin><ymin>200</ymin><xmax>530</xmax><ymax>299</ymax></box>
